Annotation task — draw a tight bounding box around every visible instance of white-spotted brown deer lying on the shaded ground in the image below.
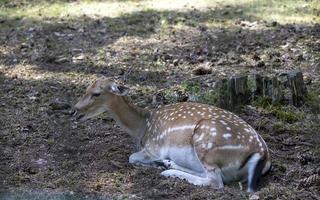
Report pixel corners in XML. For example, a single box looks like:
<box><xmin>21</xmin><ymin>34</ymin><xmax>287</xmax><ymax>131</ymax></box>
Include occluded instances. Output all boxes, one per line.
<box><xmin>74</xmin><ymin>77</ymin><xmax>271</xmax><ymax>193</ymax></box>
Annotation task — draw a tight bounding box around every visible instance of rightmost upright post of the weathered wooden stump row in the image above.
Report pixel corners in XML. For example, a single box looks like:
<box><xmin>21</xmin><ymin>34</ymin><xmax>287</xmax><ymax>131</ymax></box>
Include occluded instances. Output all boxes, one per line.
<box><xmin>288</xmin><ymin>70</ymin><xmax>307</xmax><ymax>106</ymax></box>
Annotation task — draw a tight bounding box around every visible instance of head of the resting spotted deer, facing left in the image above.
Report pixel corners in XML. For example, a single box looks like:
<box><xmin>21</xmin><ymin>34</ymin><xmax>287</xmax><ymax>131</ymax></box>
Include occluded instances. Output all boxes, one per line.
<box><xmin>75</xmin><ymin>78</ymin><xmax>129</xmax><ymax>121</ymax></box>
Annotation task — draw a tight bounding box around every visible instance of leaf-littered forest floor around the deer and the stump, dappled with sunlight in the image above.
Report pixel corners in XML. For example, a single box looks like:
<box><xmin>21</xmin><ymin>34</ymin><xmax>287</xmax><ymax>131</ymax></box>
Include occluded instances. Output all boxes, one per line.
<box><xmin>0</xmin><ymin>0</ymin><xmax>320</xmax><ymax>200</ymax></box>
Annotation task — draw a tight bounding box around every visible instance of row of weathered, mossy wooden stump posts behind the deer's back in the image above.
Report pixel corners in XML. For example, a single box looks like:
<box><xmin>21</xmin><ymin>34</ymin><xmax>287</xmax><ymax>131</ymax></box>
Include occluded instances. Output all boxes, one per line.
<box><xmin>217</xmin><ymin>70</ymin><xmax>307</xmax><ymax>110</ymax></box>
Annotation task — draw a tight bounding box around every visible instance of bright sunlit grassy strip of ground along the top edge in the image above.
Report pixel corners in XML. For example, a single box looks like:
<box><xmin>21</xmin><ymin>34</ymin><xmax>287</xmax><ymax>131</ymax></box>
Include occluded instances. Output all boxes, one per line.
<box><xmin>0</xmin><ymin>0</ymin><xmax>320</xmax><ymax>28</ymax></box>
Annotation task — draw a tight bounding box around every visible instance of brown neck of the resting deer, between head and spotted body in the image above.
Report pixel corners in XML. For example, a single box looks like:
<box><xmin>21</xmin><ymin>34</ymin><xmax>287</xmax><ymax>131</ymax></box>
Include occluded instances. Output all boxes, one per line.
<box><xmin>110</xmin><ymin>96</ymin><xmax>150</xmax><ymax>143</ymax></box>
